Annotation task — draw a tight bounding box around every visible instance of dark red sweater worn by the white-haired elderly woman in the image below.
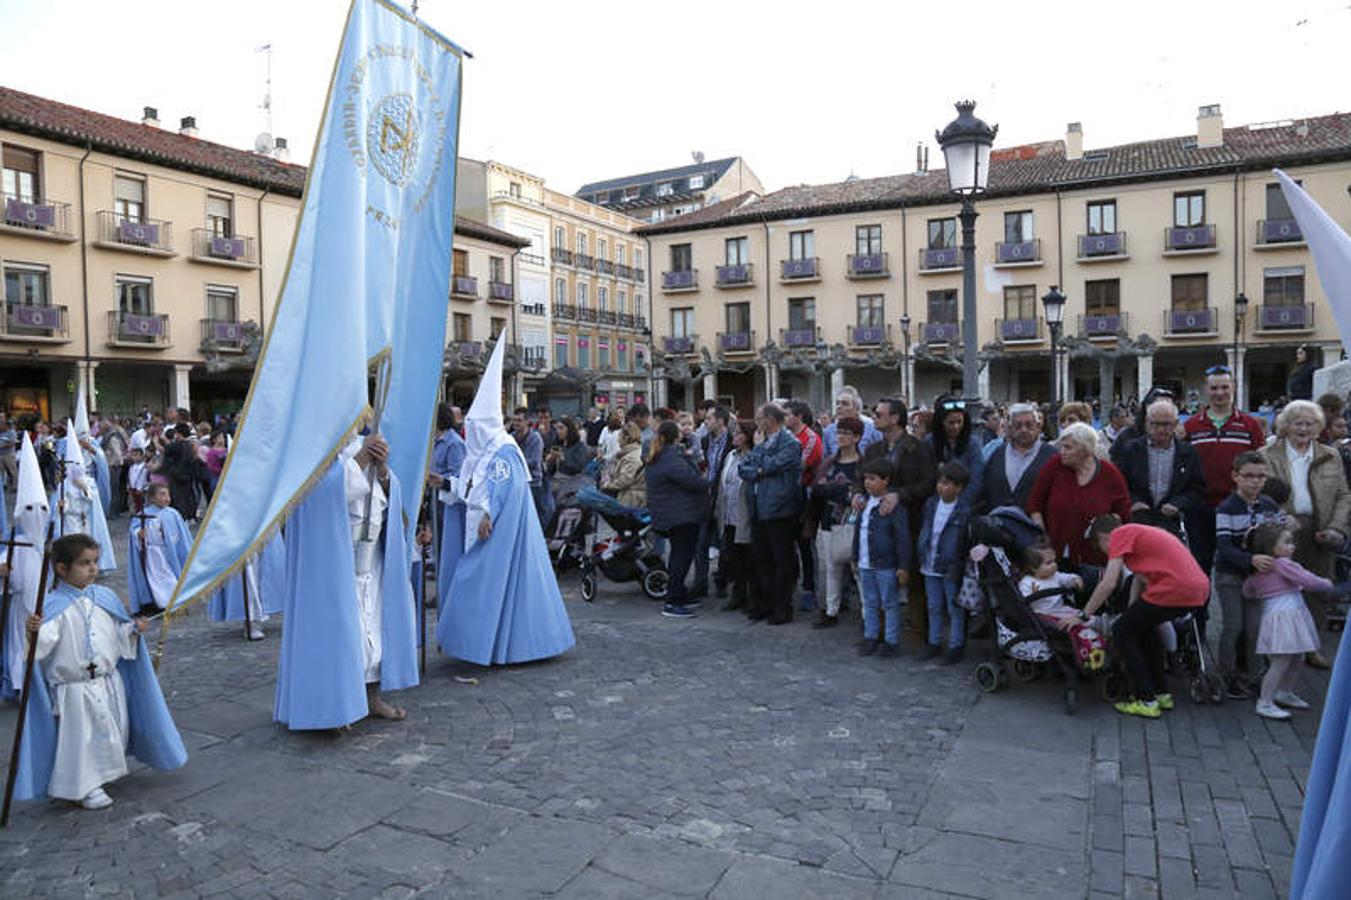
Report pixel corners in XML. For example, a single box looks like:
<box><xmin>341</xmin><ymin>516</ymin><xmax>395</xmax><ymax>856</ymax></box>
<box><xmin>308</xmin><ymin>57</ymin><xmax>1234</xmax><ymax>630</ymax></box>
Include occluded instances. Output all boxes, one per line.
<box><xmin>1027</xmin><ymin>454</ymin><xmax>1131</xmax><ymax>566</ymax></box>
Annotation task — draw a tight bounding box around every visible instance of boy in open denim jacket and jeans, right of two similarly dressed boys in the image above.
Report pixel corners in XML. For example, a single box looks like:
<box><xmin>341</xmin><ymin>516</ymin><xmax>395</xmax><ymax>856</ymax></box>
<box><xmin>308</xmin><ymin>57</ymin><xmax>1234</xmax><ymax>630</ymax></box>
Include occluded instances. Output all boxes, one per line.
<box><xmin>919</xmin><ymin>462</ymin><xmax>971</xmax><ymax>665</ymax></box>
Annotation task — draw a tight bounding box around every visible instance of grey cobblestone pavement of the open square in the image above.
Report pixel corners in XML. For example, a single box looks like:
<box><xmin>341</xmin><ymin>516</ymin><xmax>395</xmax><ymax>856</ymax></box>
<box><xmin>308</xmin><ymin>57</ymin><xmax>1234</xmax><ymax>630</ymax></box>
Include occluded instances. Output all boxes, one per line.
<box><xmin>0</xmin><ymin>524</ymin><xmax>1325</xmax><ymax>900</ymax></box>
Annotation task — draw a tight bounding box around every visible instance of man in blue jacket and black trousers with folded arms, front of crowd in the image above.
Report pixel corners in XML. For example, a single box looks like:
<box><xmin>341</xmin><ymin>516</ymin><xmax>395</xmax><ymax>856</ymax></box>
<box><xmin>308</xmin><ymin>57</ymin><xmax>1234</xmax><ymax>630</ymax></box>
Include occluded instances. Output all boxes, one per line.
<box><xmin>739</xmin><ymin>403</ymin><xmax>802</xmax><ymax>624</ymax></box>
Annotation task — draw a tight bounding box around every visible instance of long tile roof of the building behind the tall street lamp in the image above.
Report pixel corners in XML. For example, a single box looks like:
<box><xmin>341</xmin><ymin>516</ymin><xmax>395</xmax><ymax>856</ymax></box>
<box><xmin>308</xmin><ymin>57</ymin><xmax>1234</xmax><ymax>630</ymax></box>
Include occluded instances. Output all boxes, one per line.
<box><xmin>638</xmin><ymin>112</ymin><xmax>1351</xmax><ymax>235</ymax></box>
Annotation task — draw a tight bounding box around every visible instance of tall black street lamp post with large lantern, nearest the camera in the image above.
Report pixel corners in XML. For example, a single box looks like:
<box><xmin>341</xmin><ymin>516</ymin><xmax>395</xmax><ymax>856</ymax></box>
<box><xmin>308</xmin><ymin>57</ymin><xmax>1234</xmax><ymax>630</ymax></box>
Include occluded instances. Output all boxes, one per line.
<box><xmin>935</xmin><ymin>100</ymin><xmax>1000</xmax><ymax>397</ymax></box>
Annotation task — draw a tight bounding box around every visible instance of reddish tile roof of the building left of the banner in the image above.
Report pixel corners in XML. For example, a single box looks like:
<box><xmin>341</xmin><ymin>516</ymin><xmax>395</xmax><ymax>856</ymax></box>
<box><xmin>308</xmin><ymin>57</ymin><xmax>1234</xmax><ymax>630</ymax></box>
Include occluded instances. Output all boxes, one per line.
<box><xmin>0</xmin><ymin>86</ymin><xmax>305</xmax><ymax>197</ymax></box>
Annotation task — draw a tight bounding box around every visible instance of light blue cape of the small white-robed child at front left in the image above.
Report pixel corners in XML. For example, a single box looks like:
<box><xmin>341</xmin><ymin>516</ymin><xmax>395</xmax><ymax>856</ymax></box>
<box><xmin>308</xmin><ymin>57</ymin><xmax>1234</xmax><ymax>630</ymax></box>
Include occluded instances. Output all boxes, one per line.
<box><xmin>14</xmin><ymin>584</ymin><xmax>188</xmax><ymax>800</ymax></box>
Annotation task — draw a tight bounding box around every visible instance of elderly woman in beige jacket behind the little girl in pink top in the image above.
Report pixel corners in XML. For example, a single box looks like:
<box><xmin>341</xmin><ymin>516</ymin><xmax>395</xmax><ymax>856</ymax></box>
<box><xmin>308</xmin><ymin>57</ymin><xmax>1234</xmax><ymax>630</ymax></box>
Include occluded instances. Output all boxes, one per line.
<box><xmin>1260</xmin><ymin>400</ymin><xmax>1351</xmax><ymax>669</ymax></box>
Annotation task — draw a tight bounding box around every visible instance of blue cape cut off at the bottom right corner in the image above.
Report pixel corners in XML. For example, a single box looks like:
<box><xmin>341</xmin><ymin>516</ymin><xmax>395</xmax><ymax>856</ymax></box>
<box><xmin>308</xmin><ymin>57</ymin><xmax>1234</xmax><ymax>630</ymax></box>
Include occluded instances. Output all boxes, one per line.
<box><xmin>1290</xmin><ymin>632</ymin><xmax>1351</xmax><ymax>900</ymax></box>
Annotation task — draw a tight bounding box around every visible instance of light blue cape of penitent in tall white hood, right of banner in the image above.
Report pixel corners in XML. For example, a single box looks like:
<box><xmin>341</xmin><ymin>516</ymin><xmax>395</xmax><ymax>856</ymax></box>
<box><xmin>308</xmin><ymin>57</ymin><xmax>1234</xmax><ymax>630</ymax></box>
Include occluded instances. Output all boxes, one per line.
<box><xmin>436</xmin><ymin>445</ymin><xmax>577</xmax><ymax>665</ymax></box>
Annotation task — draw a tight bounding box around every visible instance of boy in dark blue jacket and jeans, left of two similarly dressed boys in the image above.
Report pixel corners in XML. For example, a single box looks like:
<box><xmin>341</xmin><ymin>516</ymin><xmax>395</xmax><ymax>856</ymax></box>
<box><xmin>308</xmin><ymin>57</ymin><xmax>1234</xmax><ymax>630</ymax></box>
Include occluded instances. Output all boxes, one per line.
<box><xmin>854</xmin><ymin>457</ymin><xmax>911</xmax><ymax>657</ymax></box>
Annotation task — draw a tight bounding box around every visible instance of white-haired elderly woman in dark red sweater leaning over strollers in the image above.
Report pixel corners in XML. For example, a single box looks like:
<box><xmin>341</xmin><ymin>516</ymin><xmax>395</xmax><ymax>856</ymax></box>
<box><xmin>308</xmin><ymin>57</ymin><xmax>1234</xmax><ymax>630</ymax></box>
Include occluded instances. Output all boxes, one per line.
<box><xmin>1027</xmin><ymin>422</ymin><xmax>1131</xmax><ymax>566</ymax></box>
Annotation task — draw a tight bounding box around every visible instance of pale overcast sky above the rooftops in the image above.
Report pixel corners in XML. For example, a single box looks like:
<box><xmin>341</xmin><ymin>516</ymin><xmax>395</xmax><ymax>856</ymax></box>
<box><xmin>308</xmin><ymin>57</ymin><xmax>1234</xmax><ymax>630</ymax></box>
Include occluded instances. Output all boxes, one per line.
<box><xmin>0</xmin><ymin>0</ymin><xmax>1351</xmax><ymax>192</ymax></box>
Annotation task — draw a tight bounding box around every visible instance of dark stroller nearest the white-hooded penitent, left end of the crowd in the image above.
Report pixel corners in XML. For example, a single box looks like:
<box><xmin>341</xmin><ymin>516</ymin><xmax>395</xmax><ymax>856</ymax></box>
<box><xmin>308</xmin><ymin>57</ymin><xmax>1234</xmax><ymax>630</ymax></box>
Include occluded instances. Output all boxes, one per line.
<box><xmin>574</xmin><ymin>488</ymin><xmax>670</xmax><ymax>603</ymax></box>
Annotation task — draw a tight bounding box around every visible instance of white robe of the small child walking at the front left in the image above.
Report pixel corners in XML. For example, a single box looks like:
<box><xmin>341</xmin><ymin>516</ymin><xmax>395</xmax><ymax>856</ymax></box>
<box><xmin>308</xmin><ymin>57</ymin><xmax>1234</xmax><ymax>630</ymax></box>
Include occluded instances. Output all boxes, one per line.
<box><xmin>36</xmin><ymin>597</ymin><xmax>136</xmax><ymax>800</ymax></box>
